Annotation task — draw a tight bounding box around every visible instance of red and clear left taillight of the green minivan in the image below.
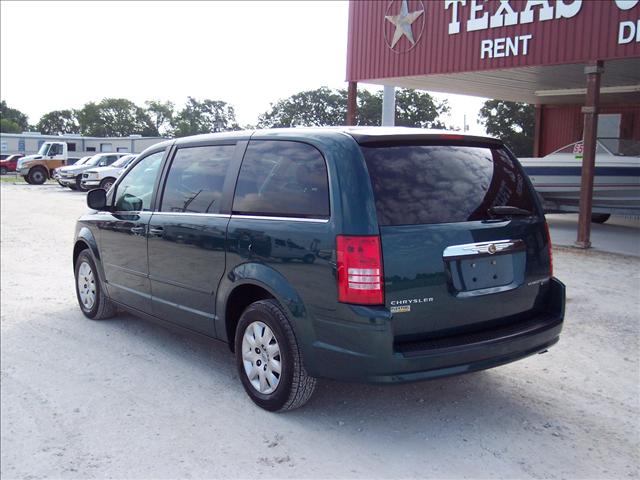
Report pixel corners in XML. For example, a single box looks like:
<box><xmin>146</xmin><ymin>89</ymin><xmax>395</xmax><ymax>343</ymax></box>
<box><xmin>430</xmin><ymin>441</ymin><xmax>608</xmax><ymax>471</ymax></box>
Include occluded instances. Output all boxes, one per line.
<box><xmin>336</xmin><ymin>235</ymin><xmax>384</xmax><ymax>305</ymax></box>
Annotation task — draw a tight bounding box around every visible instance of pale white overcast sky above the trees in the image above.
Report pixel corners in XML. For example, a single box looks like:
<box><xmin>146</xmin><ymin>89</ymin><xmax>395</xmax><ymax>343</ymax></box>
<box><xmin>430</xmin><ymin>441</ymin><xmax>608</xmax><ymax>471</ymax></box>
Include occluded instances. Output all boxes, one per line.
<box><xmin>0</xmin><ymin>1</ymin><xmax>484</xmax><ymax>134</ymax></box>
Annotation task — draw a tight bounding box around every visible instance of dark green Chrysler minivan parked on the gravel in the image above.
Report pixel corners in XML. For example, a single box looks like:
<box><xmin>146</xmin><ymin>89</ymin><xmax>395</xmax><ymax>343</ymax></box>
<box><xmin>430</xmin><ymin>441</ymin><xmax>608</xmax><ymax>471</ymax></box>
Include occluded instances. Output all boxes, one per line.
<box><xmin>73</xmin><ymin>127</ymin><xmax>565</xmax><ymax>411</ymax></box>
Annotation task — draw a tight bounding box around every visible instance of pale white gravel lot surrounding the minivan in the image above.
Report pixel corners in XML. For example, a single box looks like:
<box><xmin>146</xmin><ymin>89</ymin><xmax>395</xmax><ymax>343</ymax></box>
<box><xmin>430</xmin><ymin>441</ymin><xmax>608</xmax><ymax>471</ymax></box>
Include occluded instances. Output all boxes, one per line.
<box><xmin>0</xmin><ymin>183</ymin><xmax>640</xmax><ymax>479</ymax></box>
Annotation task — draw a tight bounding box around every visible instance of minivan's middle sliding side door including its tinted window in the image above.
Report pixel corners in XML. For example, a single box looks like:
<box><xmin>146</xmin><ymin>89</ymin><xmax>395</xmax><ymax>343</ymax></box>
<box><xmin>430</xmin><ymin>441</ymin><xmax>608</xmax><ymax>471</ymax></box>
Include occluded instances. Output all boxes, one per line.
<box><xmin>148</xmin><ymin>144</ymin><xmax>236</xmax><ymax>336</ymax></box>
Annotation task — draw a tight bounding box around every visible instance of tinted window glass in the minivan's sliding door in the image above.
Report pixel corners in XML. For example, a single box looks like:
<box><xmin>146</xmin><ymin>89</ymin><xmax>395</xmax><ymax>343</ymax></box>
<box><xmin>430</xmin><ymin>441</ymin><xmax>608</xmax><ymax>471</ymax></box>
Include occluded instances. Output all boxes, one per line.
<box><xmin>161</xmin><ymin>145</ymin><xmax>236</xmax><ymax>213</ymax></box>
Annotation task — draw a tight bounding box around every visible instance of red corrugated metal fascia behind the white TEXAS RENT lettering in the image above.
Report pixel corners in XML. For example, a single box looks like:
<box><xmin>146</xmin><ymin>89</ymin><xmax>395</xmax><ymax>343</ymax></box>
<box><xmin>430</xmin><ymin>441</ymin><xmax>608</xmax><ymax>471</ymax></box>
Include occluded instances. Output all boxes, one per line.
<box><xmin>347</xmin><ymin>0</ymin><xmax>640</xmax><ymax>81</ymax></box>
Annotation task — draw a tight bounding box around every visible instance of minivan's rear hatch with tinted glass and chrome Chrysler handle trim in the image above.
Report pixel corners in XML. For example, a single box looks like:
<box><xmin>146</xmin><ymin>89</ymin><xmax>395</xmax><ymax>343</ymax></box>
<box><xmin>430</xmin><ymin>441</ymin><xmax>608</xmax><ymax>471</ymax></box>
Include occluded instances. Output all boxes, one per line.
<box><xmin>361</xmin><ymin>139</ymin><xmax>551</xmax><ymax>342</ymax></box>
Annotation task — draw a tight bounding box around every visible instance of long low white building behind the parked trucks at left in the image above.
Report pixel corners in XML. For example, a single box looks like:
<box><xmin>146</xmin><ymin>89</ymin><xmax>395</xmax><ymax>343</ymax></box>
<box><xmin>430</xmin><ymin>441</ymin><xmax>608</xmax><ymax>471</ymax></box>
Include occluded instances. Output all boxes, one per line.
<box><xmin>0</xmin><ymin>132</ymin><xmax>166</xmax><ymax>158</ymax></box>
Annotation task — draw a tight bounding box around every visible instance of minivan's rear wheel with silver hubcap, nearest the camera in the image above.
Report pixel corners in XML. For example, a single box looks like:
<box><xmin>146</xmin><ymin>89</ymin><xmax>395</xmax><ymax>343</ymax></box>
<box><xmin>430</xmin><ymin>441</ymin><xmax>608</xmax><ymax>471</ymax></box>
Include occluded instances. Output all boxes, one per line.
<box><xmin>235</xmin><ymin>300</ymin><xmax>316</xmax><ymax>412</ymax></box>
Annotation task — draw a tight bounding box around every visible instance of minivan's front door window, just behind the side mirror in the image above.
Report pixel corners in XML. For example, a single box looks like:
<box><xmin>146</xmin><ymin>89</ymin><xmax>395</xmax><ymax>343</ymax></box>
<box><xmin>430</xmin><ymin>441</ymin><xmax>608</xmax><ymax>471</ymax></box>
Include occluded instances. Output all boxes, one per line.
<box><xmin>114</xmin><ymin>151</ymin><xmax>164</xmax><ymax>212</ymax></box>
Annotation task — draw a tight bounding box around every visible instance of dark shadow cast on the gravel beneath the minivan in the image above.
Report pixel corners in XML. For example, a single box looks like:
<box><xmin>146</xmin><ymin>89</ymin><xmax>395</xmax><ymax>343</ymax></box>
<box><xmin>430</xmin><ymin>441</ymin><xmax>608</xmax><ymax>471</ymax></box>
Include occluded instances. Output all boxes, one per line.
<box><xmin>95</xmin><ymin>308</ymin><xmax>557</xmax><ymax>441</ymax></box>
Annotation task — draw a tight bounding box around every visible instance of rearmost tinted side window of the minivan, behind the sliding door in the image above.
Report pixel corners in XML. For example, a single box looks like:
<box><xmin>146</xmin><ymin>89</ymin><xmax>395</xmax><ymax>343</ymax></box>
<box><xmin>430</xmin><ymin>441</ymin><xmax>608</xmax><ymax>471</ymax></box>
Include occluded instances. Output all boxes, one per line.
<box><xmin>233</xmin><ymin>141</ymin><xmax>329</xmax><ymax>218</ymax></box>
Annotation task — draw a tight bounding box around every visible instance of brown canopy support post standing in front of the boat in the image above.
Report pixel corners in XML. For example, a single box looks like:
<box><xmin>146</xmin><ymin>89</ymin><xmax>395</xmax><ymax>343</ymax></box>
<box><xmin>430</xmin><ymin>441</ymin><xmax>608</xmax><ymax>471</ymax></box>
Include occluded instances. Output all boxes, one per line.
<box><xmin>575</xmin><ymin>60</ymin><xmax>604</xmax><ymax>248</ymax></box>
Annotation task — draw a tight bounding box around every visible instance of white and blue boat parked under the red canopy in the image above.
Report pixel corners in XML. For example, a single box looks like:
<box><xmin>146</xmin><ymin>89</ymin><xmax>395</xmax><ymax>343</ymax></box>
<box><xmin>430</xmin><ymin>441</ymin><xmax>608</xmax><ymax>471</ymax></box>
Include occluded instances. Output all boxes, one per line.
<box><xmin>521</xmin><ymin>138</ymin><xmax>640</xmax><ymax>223</ymax></box>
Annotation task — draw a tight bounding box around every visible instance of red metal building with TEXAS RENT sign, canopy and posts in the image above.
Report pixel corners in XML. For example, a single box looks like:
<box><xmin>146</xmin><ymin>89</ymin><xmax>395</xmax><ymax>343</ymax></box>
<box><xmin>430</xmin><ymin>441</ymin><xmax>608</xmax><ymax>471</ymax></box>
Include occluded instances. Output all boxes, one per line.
<box><xmin>347</xmin><ymin>0</ymin><xmax>640</xmax><ymax>247</ymax></box>
